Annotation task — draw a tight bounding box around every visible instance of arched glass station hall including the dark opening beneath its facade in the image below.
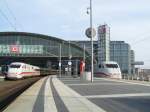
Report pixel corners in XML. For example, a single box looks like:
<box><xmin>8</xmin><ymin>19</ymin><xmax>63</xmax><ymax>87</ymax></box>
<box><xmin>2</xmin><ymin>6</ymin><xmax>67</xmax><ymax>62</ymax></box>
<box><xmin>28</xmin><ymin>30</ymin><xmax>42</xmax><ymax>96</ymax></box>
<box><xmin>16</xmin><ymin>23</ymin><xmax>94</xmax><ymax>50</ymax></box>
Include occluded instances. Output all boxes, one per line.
<box><xmin>0</xmin><ymin>32</ymin><xmax>88</xmax><ymax>67</ymax></box>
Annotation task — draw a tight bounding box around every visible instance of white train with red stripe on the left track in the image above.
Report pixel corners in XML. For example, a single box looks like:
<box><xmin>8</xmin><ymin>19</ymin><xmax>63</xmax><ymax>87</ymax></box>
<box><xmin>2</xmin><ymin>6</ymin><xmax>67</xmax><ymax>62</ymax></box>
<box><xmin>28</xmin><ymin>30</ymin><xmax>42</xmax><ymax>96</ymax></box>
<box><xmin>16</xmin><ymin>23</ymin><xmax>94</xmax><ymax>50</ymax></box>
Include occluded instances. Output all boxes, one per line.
<box><xmin>7</xmin><ymin>62</ymin><xmax>40</xmax><ymax>79</ymax></box>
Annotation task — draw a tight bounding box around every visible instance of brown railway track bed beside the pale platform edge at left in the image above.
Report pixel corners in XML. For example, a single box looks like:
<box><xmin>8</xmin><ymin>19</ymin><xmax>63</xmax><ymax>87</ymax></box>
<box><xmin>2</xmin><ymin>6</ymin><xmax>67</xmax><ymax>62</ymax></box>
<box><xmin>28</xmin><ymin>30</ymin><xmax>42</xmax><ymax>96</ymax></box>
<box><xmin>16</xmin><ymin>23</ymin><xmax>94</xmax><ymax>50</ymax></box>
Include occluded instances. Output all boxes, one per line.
<box><xmin>0</xmin><ymin>77</ymin><xmax>41</xmax><ymax>112</ymax></box>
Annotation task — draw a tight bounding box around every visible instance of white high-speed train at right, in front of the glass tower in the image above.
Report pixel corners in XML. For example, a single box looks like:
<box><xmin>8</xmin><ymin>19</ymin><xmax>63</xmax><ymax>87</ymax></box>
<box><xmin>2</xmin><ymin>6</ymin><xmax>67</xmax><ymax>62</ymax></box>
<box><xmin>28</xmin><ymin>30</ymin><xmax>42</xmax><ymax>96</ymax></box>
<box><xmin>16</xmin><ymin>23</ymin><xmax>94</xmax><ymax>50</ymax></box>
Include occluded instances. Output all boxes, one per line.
<box><xmin>94</xmin><ymin>61</ymin><xmax>122</xmax><ymax>79</ymax></box>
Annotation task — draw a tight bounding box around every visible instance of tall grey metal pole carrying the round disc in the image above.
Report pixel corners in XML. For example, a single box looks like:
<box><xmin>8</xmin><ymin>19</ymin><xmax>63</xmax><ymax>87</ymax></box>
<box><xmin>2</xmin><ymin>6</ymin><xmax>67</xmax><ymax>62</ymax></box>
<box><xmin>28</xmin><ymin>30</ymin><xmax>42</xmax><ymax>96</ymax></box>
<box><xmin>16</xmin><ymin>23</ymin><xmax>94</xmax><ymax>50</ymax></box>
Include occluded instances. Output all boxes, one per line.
<box><xmin>90</xmin><ymin>0</ymin><xmax>93</xmax><ymax>82</ymax></box>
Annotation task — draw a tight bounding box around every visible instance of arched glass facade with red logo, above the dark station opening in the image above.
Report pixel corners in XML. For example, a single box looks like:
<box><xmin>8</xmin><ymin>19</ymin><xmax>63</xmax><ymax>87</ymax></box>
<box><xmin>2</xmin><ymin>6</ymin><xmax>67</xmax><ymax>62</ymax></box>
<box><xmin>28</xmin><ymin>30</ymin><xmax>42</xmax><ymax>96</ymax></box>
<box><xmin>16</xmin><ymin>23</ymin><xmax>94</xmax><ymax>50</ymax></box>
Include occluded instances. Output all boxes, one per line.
<box><xmin>0</xmin><ymin>32</ymin><xmax>88</xmax><ymax>57</ymax></box>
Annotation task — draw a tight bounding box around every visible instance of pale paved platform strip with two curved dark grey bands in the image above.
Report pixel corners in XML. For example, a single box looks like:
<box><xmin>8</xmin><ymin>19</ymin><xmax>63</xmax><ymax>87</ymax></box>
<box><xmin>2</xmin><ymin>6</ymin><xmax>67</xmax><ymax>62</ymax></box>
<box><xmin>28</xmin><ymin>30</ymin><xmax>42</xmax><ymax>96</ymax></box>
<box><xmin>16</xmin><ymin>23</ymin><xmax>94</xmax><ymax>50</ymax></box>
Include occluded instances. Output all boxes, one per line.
<box><xmin>4</xmin><ymin>76</ymin><xmax>105</xmax><ymax>112</ymax></box>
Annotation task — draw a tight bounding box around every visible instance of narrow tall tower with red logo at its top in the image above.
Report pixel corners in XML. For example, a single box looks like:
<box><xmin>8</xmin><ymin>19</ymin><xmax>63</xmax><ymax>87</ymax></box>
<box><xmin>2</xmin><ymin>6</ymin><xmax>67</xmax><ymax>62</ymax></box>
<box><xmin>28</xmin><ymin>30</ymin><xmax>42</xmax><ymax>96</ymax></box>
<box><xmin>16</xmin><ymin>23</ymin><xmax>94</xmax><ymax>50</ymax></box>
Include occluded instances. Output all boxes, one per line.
<box><xmin>98</xmin><ymin>24</ymin><xmax>110</xmax><ymax>63</ymax></box>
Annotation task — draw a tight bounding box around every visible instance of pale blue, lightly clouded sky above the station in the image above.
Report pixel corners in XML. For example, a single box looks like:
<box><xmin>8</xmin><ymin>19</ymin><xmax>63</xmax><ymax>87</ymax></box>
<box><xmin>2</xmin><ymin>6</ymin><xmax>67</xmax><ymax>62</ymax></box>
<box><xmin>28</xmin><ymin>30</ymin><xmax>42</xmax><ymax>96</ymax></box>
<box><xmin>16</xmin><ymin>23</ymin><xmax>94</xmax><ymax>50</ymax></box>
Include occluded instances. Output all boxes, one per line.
<box><xmin>0</xmin><ymin>0</ymin><xmax>150</xmax><ymax>68</ymax></box>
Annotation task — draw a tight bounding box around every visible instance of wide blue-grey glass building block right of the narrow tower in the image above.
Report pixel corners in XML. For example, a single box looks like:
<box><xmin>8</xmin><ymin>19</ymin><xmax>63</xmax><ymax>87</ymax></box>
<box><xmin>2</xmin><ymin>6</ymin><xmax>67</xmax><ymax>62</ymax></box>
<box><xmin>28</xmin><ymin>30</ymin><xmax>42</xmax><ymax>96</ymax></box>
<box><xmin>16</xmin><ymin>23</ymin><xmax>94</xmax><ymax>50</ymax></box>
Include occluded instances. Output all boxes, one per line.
<box><xmin>110</xmin><ymin>41</ymin><xmax>134</xmax><ymax>74</ymax></box>
